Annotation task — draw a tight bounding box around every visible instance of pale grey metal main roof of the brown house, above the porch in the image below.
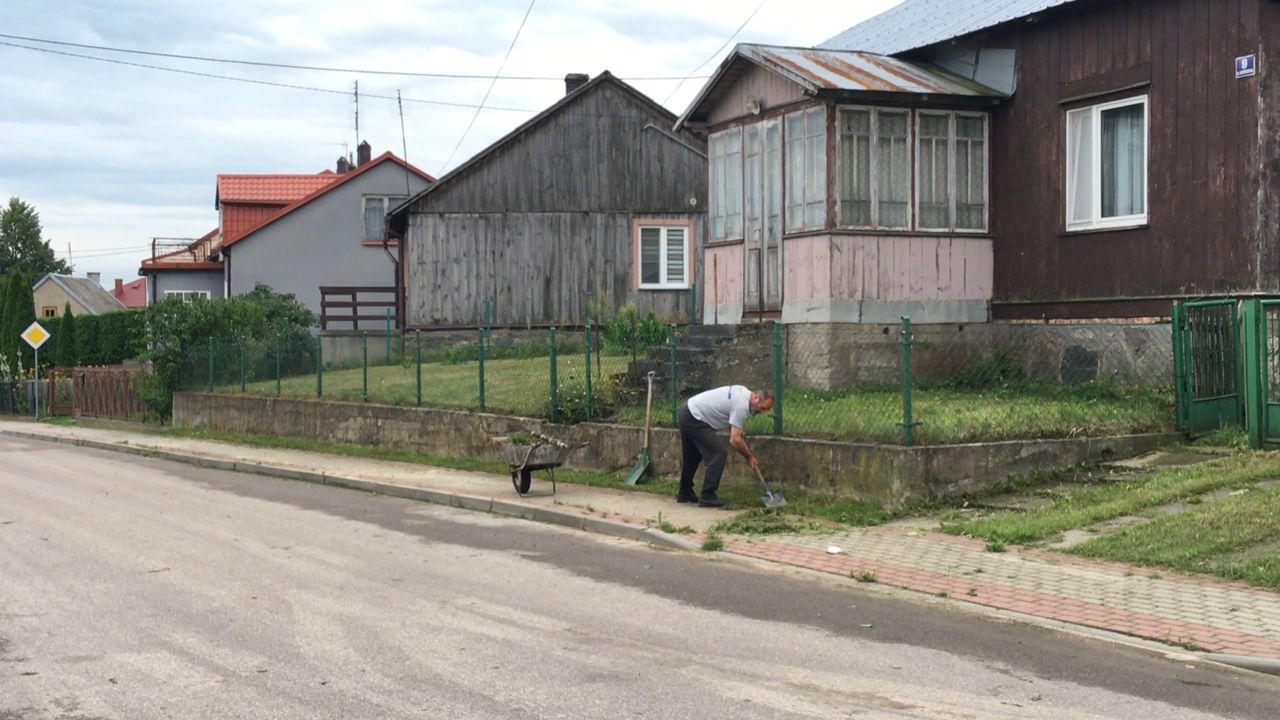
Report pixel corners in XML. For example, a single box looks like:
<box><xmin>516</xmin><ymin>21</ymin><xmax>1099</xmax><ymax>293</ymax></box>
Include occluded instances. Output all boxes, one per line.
<box><xmin>818</xmin><ymin>0</ymin><xmax>1075</xmax><ymax>55</ymax></box>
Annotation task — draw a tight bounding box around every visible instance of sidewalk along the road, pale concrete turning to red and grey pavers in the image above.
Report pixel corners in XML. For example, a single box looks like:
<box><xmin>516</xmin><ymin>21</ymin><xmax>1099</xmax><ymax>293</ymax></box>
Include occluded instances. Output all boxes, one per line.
<box><xmin>0</xmin><ymin>420</ymin><xmax>1280</xmax><ymax>673</ymax></box>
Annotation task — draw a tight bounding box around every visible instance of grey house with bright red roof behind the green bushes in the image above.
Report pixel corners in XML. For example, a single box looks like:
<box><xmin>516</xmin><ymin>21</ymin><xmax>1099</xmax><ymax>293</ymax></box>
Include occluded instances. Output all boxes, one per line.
<box><xmin>140</xmin><ymin>142</ymin><xmax>434</xmax><ymax>315</ymax></box>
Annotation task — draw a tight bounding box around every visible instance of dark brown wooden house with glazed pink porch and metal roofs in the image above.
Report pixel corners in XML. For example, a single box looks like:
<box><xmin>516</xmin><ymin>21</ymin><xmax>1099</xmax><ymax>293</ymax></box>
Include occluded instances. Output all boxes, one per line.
<box><xmin>677</xmin><ymin>0</ymin><xmax>1280</xmax><ymax>323</ymax></box>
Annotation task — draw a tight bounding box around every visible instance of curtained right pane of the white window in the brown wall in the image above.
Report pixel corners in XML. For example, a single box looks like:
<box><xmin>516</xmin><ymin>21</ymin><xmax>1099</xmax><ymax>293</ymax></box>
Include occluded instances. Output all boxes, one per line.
<box><xmin>1102</xmin><ymin>105</ymin><xmax>1147</xmax><ymax>218</ymax></box>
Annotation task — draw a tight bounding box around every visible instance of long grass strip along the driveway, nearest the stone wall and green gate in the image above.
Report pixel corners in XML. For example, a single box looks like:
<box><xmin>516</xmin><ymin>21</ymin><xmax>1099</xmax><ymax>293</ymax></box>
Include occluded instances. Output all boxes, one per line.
<box><xmin>942</xmin><ymin>452</ymin><xmax>1277</xmax><ymax>543</ymax></box>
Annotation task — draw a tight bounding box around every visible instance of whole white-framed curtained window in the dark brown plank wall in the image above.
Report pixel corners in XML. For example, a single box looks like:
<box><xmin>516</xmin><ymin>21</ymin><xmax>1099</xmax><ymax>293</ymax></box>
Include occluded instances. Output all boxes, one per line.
<box><xmin>1066</xmin><ymin>96</ymin><xmax>1148</xmax><ymax>231</ymax></box>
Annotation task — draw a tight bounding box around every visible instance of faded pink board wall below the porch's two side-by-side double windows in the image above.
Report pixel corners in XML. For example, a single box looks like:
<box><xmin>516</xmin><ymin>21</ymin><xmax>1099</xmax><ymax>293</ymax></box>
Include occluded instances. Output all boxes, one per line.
<box><xmin>782</xmin><ymin>234</ymin><xmax>993</xmax><ymax>301</ymax></box>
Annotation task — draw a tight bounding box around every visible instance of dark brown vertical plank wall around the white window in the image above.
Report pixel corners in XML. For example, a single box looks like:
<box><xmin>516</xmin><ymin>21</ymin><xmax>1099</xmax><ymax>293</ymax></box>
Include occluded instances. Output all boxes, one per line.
<box><xmin>970</xmin><ymin>0</ymin><xmax>1280</xmax><ymax>318</ymax></box>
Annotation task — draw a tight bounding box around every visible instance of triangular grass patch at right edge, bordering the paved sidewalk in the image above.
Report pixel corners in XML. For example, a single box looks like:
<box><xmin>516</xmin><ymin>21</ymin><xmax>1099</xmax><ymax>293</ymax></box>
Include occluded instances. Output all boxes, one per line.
<box><xmin>1068</xmin><ymin>487</ymin><xmax>1280</xmax><ymax>591</ymax></box>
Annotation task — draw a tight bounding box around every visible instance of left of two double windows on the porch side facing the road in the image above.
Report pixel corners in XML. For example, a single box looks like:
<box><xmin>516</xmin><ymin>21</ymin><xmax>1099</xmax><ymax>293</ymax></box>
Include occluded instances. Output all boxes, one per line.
<box><xmin>837</xmin><ymin>108</ymin><xmax>911</xmax><ymax>229</ymax></box>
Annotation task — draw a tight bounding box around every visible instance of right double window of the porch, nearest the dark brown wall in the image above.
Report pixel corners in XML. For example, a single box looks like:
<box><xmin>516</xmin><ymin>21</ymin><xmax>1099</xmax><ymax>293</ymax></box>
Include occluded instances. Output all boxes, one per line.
<box><xmin>915</xmin><ymin>111</ymin><xmax>987</xmax><ymax>231</ymax></box>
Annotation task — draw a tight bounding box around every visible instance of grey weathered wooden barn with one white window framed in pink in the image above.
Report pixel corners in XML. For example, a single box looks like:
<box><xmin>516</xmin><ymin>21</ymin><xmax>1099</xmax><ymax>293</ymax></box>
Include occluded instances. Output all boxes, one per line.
<box><xmin>390</xmin><ymin>72</ymin><xmax>707</xmax><ymax>329</ymax></box>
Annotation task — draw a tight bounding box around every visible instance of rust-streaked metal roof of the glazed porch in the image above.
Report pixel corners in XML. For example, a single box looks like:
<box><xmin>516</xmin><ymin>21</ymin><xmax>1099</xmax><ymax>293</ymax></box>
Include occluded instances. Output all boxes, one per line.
<box><xmin>736</xmin><ymin>44</ymin><xmax>1004</xmax><ymax>97</ymax></box>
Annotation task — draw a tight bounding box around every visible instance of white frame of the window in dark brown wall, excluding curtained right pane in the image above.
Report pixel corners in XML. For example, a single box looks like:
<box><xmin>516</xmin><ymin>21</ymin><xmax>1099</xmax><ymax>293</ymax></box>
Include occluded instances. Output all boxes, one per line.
<box><xmin>1062</xmin><ymin>95</ymin><xmax>1151</xmax><ymax>232</ymax></box>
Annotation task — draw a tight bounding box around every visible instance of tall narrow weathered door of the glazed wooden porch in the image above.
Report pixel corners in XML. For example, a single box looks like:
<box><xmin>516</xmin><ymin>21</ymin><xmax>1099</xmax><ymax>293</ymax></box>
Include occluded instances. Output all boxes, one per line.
<box><xmin>742</xmin><ymin>119</ymin><xmax>782</xmax><ymax>313</ymax></box>
